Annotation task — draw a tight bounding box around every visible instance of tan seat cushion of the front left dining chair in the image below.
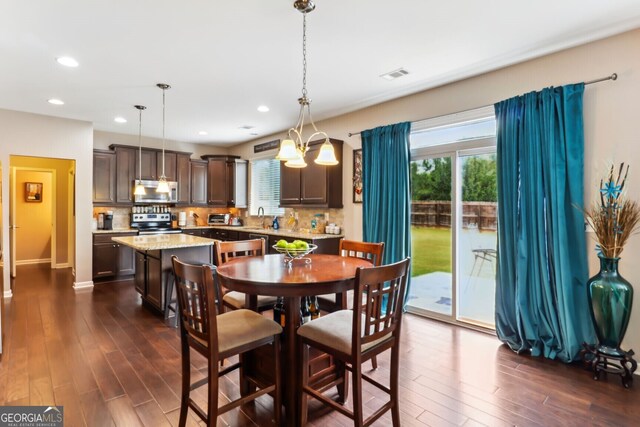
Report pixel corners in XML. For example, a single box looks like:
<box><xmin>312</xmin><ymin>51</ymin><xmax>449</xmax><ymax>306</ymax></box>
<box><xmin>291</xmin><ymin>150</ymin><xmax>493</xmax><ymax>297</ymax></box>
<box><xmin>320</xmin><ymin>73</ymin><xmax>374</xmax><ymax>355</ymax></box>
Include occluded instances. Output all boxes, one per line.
<box><xmin>217</xmin><ymin>310</ymin><xmax>282</xmax><ymax>353</ymax></box>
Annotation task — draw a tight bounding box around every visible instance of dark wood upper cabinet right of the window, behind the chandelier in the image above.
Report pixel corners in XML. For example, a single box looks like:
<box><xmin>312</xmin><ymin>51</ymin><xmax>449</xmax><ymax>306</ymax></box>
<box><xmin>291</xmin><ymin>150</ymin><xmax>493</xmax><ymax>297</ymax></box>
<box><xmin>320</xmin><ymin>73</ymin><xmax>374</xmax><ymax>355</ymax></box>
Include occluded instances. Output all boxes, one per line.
<box><xmin>280</xmin><ymin>139</ymin><xmax>343</xmax><ymax>208</ymax></box>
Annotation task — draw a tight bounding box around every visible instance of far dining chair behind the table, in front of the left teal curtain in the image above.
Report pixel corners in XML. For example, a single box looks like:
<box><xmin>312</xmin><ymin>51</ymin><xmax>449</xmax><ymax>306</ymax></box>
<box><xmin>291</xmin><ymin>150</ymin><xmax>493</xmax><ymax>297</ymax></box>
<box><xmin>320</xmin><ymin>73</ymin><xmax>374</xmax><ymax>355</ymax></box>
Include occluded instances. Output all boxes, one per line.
<box><xmin>318</xmin><ymin>239</ymin><xmax>384</xmax><ymax>369</ymax></box>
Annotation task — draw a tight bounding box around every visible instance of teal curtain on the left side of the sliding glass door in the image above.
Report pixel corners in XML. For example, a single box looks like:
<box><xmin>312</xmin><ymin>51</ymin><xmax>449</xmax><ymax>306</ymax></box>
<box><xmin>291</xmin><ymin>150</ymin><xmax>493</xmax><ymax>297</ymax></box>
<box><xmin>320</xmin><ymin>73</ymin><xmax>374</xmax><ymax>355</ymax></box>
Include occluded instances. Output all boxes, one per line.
<box><xmin>360</xmin><ymin>122</ymin><xmax>411</xmax><ymax>306</ymax></box>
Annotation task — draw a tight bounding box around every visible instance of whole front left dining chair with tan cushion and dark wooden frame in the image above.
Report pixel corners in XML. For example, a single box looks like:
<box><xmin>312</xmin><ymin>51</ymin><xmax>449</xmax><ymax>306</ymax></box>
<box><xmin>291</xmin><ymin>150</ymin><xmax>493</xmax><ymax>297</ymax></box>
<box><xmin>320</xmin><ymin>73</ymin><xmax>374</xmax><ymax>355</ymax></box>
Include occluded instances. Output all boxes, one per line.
<box><xmin>171</xmin><ymin>255</ymin><xmax>282</xmax><ymax>427</ymax></box>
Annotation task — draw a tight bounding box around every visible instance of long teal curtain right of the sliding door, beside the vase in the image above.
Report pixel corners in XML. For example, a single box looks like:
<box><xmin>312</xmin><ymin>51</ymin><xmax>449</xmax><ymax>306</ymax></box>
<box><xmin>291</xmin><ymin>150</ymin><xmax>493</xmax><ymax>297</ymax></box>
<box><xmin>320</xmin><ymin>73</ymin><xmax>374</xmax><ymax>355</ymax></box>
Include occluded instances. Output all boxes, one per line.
<box><xmin>495</xmin><ymin>83</ymin><xmax>595</xmax><ymax>362</ymax></box>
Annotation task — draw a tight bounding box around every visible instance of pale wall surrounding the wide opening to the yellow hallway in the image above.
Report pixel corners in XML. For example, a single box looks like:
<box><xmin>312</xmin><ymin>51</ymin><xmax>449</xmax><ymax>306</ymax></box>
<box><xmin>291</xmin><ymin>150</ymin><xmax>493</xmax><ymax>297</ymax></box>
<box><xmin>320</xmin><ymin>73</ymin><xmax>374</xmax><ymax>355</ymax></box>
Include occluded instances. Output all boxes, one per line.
<box><xmin>0</xmin><ymin>109</ymin><xmax>93</xmax><ymax>294</ymax></box>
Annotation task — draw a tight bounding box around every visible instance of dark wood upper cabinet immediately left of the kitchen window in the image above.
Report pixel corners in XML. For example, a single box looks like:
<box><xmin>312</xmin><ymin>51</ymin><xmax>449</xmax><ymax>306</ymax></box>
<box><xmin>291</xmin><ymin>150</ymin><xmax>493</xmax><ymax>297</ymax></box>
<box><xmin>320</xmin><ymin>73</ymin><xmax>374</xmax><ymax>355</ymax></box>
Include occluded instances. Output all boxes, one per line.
<box><xmin>202</xmin><ymin>155</ymin><xmax>247</xmax><ymax>208</ymax></box>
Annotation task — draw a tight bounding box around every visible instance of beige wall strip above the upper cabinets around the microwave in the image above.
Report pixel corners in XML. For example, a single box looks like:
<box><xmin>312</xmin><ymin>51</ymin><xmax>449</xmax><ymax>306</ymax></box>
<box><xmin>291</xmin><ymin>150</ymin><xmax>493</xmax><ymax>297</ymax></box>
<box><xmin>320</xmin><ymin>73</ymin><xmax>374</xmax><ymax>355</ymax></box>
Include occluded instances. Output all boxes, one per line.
<box><xmin>93</xmin><ymin>130</ymin><xmax>228</xmax><ymax>159</ymax></box>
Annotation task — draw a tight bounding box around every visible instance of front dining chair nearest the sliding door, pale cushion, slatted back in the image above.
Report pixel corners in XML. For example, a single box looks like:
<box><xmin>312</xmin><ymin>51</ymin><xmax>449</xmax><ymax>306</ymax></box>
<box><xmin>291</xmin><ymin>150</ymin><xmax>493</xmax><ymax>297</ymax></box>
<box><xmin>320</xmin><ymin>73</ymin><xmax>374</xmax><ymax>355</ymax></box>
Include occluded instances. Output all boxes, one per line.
<box><xmin>297</xmin><ymin>258</ymin><xmax>410</xmax><ymax>426</ymax></box>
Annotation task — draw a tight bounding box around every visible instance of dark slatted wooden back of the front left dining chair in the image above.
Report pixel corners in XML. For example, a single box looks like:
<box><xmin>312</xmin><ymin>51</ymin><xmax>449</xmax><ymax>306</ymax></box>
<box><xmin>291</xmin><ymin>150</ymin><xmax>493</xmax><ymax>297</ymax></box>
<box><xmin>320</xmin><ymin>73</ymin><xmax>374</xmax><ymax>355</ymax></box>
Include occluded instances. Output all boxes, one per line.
<box><xmin>171</xmin><ymin>255</ymin><xmax>222</xmax><ymax>349</ymax></box>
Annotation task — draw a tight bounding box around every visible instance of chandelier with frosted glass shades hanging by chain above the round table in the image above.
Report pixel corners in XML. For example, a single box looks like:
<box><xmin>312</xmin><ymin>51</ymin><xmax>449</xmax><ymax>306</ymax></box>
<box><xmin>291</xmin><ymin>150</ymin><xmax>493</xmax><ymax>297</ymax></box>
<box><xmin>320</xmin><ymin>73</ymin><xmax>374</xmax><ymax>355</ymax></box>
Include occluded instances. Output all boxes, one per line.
<box><xmin>276</xmin><ymin>0</ymin><xmax>338</xmax><ymax>168</ymax></box>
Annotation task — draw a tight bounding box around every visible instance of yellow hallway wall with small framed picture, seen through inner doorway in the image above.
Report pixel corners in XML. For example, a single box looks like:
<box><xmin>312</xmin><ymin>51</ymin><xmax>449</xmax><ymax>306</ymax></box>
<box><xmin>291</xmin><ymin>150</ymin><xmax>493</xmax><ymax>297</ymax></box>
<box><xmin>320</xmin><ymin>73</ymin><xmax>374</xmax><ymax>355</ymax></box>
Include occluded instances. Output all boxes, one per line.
<box><xmin>15</xmin><ymin>169</ymin><xmax>53</xmax><ymax>264</ymax></box>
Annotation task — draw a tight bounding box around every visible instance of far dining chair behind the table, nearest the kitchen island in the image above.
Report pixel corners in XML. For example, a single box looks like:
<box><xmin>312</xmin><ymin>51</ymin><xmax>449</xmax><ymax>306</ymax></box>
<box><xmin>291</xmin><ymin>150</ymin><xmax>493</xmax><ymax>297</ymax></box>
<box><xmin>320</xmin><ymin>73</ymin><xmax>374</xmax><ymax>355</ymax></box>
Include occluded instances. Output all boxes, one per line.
<box><xmin>214</xmin><ymin>239</ymin><xmax>277</xmax><ymax>312</ymax></box>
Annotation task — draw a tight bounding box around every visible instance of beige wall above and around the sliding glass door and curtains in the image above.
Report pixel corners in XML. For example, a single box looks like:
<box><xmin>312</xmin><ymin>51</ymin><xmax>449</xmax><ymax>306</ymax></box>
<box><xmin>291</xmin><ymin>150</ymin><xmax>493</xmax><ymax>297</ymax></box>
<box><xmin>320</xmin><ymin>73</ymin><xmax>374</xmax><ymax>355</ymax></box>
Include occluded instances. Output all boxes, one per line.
<box><xmin>230</xmin><ymin>30</ymin><xmax>640</xmax><ymax>356</ymax></box>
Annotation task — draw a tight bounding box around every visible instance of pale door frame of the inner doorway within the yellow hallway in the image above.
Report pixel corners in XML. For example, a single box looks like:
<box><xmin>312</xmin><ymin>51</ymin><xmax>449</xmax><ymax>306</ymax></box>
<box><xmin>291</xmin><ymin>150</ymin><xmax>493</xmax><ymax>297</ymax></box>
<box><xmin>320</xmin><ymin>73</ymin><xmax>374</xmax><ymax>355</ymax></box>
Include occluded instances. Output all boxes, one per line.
<box><xmin>9</xmin><ymin>166</ymin><xmax>57</xmax><ymax>277</ymax></box>
